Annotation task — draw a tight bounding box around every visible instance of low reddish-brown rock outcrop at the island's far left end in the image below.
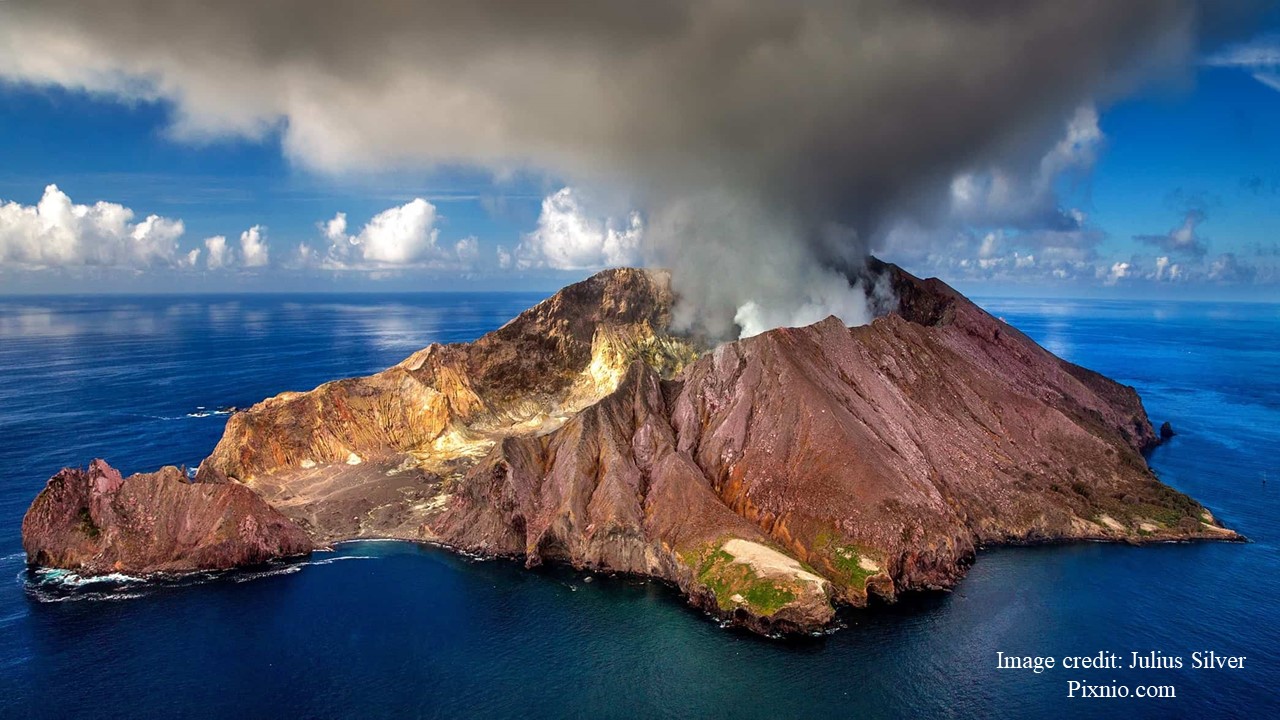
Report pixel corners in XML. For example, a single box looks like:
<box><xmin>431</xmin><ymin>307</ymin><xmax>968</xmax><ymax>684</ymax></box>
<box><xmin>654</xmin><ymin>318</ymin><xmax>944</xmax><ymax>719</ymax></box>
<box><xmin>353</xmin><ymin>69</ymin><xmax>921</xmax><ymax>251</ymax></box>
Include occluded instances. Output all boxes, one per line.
<box><xmin>22</xmin><ymin>460</ymin><xmax>312</xmax><ymax>575</ymax></box>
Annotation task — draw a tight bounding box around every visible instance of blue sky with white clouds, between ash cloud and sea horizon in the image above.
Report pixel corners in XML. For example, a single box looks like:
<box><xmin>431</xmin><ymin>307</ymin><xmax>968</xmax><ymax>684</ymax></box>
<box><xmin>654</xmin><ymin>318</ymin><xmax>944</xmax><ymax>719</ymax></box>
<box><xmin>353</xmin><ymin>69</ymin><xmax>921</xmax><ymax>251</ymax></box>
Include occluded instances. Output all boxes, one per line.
<box><xmin>0</xmin><ymin>4</ymin><xmax>1280</xmax><ymax>301</ymax></box>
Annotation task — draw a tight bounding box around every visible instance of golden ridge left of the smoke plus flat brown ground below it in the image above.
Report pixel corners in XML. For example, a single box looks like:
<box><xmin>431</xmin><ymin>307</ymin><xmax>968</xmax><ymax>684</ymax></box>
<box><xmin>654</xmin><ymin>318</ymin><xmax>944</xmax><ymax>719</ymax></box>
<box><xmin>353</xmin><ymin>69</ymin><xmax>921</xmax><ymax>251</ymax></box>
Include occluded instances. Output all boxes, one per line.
<box><xmin>186</xmin><ymin>268</ymin><xmax>699</xmax><ymax>542</ymax></box>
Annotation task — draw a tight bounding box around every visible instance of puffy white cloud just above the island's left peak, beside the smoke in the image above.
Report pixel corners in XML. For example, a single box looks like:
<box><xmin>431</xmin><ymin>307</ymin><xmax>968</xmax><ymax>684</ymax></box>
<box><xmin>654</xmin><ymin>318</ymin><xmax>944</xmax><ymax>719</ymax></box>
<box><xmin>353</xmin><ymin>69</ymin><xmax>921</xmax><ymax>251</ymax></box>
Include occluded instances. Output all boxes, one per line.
<box><xmin>509</xmin><ymin>187</ymin><xmax>644</xmax><ymax>270</ymax></box>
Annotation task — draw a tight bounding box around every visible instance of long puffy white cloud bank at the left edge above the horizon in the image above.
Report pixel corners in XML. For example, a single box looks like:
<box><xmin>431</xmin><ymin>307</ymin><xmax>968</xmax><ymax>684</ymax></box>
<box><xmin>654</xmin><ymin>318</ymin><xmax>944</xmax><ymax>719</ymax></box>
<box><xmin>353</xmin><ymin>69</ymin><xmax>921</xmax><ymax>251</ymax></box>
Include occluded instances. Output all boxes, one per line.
<box><xmin>0</xmin><ymin>184</ymin><xmax>187</xmax><ymax>269</ymax></box>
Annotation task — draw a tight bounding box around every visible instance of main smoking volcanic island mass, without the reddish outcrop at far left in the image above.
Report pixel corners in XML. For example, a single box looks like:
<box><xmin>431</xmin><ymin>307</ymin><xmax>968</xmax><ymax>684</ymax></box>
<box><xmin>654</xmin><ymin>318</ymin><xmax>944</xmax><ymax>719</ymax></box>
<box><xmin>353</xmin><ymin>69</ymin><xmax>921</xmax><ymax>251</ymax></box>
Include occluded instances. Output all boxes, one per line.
<box><xmin>24</xmin><ymin>261</ymin><xmax>1238</xmax><ymax>632</ymax></box>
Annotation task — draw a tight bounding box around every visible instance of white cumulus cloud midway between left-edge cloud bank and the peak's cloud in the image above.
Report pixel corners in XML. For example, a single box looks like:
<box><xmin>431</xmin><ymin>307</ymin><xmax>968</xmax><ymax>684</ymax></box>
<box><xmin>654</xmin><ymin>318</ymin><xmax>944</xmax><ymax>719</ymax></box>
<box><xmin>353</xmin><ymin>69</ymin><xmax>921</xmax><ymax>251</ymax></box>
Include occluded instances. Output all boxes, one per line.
<box><xmin>308</xmin><ymin>197</ymin><xmax>480</xmax><ymax>270</ymax></box>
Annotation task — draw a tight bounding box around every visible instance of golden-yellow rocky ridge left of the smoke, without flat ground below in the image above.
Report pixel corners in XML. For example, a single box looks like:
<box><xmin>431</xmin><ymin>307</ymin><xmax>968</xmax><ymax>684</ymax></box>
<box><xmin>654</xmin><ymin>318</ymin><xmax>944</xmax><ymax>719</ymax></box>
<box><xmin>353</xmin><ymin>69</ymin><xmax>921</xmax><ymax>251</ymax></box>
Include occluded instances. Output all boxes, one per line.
<box><xmin>198</xmin><ymin>269</ymin><xmax>698</xmax><ymax>484</ymax></box>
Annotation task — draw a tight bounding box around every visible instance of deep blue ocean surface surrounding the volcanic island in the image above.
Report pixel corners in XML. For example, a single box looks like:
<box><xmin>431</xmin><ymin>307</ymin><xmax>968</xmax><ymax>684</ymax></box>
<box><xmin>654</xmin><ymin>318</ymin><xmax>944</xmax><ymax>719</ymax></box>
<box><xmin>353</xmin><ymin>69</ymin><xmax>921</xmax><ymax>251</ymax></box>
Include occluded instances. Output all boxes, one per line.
<box><xmin>0</xmin><ymin>295</ymin><xmax>1280</xmax><ymax>719</ymax></box>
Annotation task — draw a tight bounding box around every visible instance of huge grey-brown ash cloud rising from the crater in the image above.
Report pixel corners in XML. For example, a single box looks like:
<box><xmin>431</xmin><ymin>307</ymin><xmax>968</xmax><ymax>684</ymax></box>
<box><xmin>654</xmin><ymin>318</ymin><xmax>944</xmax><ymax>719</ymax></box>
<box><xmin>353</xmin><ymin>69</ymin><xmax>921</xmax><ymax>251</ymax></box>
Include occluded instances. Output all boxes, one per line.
<box><xmin>0</xmin><ymin>0</ymin><xmax>1259</xmax><ymax>336</ymax></box>
